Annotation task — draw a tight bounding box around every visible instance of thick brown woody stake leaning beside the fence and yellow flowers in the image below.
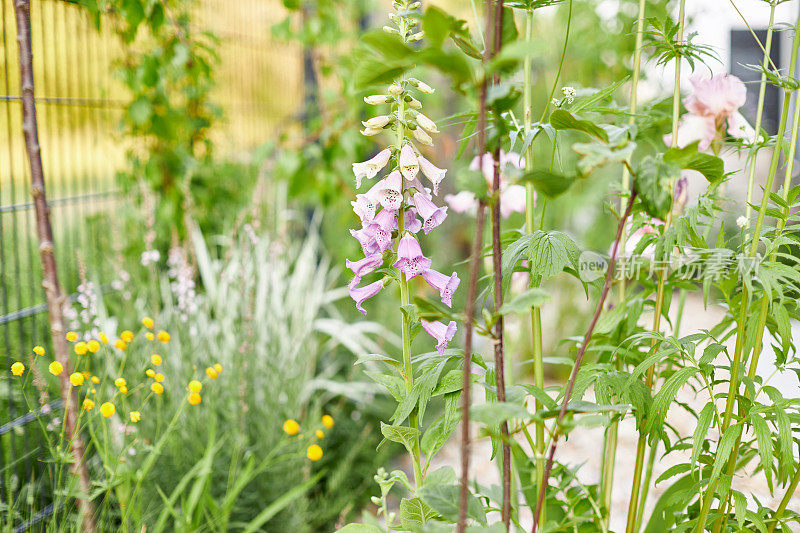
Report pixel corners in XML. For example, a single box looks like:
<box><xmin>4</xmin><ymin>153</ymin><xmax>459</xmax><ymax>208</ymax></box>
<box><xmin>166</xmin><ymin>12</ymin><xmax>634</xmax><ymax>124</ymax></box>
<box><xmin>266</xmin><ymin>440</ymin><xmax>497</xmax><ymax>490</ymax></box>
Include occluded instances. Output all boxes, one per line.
<box><xmin>14</xmin><ymin>0</ymin><xmax>97</xmax><ymax>533</ymax></box>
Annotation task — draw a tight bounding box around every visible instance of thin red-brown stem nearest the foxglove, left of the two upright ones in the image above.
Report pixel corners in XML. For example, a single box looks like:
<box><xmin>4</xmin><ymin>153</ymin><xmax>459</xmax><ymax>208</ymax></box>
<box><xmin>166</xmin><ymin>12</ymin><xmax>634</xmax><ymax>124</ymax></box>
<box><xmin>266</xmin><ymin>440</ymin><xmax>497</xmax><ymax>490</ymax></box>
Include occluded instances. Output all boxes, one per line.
<box><xmin>456</xmin><ymin>0</ymin><xmax>505</xmax><ymax>533</ymax></box>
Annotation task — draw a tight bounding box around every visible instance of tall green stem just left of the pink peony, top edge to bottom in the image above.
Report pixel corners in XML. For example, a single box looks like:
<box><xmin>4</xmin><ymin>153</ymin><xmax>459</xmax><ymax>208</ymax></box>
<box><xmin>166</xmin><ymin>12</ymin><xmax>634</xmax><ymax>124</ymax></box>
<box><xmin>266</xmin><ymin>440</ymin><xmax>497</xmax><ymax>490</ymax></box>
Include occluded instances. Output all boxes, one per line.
<box><xmin>626</xmin><ymin>0</ymin><xmax>686</xmax><ymax>533</ymax></box>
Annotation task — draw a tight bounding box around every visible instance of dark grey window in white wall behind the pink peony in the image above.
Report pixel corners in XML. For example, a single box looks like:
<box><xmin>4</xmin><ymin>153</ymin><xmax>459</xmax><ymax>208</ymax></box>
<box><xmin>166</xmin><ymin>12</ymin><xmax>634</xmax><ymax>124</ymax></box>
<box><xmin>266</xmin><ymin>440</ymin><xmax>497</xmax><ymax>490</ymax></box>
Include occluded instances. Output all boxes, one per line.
<box><xmin>730</xmin><ymin>30</ymin><xmax>782</xmax><ymax>135</ymax></box>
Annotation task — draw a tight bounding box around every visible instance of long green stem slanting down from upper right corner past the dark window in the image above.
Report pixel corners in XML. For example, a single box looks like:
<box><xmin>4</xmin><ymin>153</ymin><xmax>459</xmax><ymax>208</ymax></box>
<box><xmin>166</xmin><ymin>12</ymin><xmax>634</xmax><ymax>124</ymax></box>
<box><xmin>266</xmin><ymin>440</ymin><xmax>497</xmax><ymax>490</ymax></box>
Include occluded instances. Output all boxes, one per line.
<box><xmin>696</xmin><ymin>11</ymin><xmax>800</xmax><ymax>533</ymax></box>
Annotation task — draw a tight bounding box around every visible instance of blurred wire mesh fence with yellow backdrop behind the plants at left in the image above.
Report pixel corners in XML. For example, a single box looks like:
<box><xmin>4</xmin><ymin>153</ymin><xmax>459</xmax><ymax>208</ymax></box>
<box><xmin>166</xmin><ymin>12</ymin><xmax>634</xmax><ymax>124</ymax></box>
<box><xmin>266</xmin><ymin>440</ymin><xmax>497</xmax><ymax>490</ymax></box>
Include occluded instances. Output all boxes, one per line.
<box><xmin>0</xmin><ymin>0</ymin><xmax>302</xmax><ymax>530</ymax></box>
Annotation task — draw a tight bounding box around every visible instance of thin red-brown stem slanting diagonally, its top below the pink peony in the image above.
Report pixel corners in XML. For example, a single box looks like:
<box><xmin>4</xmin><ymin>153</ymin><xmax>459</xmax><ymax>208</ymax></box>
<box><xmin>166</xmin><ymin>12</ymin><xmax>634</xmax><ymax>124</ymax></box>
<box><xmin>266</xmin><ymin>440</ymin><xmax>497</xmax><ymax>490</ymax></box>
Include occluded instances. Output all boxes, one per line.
<box><xmin>531</xmin><ymin>185</ymin><xmax>636</xmax><ymax>533</ymax></box>
